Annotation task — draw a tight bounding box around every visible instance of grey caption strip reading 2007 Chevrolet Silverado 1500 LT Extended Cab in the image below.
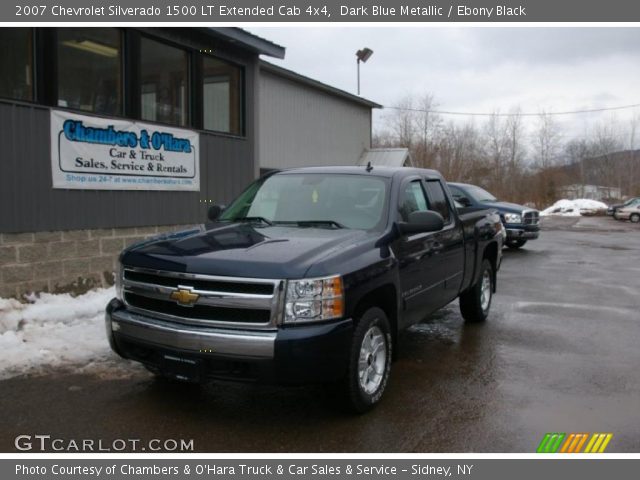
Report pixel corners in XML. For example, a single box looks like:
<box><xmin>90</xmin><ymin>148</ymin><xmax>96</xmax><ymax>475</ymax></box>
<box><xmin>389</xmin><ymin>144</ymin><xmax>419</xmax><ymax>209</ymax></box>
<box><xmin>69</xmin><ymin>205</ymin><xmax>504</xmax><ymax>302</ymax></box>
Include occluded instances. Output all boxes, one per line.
<box><xmin>6</xmin><ymin>0</ymin><xmax>640</xmax><ymax>24</ymax></box>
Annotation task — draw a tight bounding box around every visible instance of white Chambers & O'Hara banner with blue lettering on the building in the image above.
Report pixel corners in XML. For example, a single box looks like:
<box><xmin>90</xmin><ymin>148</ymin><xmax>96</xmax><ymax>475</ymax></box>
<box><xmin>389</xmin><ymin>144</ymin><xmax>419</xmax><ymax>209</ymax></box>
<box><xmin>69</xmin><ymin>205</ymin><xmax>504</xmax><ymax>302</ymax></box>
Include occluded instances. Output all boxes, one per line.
<box><xmin>51</xmin><ymin>110</ymin><xmax>200</xmax><ymax>191</ymax></box>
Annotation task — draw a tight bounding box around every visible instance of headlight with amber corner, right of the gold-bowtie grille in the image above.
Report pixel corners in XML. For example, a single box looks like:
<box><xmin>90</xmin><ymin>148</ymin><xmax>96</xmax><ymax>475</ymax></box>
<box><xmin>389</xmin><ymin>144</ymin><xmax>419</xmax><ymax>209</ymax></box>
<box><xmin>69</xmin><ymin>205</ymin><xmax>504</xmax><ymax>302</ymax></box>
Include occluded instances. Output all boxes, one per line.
<box><xmin>284</xmin><ymin>276</ymin><xmax>344</xmax><ymax>323</ymax></box>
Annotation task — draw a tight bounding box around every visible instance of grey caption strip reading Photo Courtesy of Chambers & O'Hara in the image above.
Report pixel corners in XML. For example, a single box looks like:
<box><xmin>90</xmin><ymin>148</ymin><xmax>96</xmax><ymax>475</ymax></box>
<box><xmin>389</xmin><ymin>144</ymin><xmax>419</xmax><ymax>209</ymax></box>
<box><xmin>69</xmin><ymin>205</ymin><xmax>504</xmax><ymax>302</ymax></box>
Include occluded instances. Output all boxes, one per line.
<box><xmin>0</xmin><ymin>455</ymin><xmax>640</xmax><ymax>480</ymax></box>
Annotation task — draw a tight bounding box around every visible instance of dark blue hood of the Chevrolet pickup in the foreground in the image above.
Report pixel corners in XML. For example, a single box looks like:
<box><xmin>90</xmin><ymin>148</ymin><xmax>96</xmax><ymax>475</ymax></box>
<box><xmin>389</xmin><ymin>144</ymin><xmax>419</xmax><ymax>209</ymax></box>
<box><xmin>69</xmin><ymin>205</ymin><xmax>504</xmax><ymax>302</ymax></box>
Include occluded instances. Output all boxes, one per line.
<box><xmin>121</xmin><ymin>224</ymin><xmax>369</xmax><ymax>278</ymax></box>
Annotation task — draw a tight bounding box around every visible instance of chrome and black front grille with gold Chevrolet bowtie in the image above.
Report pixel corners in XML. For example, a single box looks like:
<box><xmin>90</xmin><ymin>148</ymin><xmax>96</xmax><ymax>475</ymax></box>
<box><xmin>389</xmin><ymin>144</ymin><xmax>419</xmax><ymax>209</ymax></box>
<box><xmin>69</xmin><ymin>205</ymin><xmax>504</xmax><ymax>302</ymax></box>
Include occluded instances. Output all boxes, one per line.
<box><xmin>123</xmin><ymin>267</ymin><xmax>284</xmax><ymax>329</ymax></box>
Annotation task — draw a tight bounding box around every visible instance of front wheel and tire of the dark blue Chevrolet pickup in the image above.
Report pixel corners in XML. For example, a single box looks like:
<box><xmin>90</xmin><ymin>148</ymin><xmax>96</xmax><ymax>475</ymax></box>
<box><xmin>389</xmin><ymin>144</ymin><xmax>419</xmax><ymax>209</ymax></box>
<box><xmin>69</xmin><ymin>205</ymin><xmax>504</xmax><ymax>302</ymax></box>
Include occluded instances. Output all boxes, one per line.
<box><xmin>342</xmin><ymin>307</ymin><xmax>392</xmax><ymax>413</ymax></box>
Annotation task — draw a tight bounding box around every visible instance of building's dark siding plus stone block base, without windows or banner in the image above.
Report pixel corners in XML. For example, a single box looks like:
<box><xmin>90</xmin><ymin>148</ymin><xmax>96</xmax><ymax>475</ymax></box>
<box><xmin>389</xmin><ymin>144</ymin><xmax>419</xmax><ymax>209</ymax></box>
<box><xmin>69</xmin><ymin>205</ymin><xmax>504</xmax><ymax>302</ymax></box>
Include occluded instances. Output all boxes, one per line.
<box><xmin>0</xmin><ymin>29</ymin><xmax>259</xmax><ymax>298</ymax></box>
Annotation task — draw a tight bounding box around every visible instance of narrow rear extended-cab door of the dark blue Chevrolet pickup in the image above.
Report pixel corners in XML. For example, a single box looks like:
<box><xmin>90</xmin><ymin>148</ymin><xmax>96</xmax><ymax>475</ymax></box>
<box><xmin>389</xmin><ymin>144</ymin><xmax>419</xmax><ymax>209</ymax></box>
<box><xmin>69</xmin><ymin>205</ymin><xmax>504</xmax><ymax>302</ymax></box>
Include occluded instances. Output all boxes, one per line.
<box><xmin>424</xmin><ymin>178</ymin><xmax>464</xmax><ymax>307</ymax></box>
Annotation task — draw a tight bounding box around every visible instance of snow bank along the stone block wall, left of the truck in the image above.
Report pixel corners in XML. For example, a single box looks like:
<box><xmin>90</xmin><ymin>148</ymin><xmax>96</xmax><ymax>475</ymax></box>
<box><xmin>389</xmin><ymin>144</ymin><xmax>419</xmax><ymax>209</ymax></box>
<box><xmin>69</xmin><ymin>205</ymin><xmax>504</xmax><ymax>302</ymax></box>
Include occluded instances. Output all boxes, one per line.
<box><xmin>0</xmin><ymin>288</ymin><xmax>141</xmax><ymax>379</ymax></box>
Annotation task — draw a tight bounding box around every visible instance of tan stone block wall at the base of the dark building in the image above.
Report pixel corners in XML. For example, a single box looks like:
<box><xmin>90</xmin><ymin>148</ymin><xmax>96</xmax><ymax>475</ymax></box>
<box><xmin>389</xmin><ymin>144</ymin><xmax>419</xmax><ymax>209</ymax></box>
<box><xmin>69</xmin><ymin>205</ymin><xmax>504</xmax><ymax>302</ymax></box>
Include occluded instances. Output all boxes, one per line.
<box><xmin>0</xmin><ymin>225</ymin><xmax>198</xmax><ymax>299</ymax></box>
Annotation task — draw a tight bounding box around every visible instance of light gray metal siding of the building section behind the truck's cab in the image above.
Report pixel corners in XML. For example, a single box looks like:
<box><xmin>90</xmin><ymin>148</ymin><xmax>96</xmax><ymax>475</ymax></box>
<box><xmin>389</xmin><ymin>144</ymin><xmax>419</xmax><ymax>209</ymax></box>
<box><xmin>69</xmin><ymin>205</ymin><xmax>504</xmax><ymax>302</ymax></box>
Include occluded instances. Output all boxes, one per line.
<box><xmin>258</xmin><ymin>69</ymin><xmax>371</xmax><ymax>168</ymax></box>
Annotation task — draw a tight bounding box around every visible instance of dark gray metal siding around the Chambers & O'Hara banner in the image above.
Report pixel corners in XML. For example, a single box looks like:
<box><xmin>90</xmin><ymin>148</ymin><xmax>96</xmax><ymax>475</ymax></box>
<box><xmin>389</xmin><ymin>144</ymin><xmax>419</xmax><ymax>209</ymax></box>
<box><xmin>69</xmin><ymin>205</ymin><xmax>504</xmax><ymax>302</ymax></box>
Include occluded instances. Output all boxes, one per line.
<box><xmin>0</xmin><ymin>65</ymin><xmax>256</xmax><ymax>233</ymax></box>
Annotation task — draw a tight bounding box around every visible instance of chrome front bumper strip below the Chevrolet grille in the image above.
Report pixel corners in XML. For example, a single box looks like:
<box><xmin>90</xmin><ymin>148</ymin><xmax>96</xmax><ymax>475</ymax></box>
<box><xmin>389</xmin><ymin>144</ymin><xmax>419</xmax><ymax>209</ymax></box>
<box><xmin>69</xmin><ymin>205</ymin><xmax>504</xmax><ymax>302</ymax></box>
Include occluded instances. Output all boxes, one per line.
<box><xmin>106</xmin><ymin>310</ymin><xmax>277</xmax><ymax>359</ymax></box>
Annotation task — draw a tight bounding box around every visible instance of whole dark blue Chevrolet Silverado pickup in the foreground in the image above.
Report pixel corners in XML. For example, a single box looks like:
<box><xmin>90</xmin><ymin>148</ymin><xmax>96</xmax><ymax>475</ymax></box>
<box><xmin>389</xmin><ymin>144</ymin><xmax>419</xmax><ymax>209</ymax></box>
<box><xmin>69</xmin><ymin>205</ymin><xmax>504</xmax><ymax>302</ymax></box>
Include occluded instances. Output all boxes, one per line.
<box><xmin>106</xmin><ymin>166</ymin><xmax>503</xmax><ymax>412</ymax></box>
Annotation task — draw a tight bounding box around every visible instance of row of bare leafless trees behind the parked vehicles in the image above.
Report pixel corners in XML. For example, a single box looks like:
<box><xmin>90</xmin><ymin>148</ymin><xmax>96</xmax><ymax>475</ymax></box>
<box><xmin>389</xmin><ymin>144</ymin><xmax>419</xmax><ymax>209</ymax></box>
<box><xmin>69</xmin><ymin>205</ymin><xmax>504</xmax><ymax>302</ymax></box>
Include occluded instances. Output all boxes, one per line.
<box><xmin>373</xmin><ymin>93</ymin><xmax>640</xmax><ymax>207</ymax></box>
